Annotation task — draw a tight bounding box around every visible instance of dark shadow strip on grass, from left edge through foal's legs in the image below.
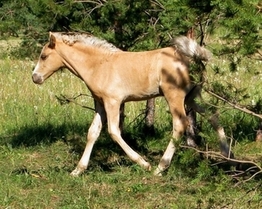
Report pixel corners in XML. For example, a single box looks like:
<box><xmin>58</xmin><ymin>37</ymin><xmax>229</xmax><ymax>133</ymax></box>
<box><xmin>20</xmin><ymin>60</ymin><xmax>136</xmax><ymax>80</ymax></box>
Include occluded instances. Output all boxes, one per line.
<box><xmin>4</xmin><ymin>121</ymin><xmax>168</xmax><ymax>172</ymax></box>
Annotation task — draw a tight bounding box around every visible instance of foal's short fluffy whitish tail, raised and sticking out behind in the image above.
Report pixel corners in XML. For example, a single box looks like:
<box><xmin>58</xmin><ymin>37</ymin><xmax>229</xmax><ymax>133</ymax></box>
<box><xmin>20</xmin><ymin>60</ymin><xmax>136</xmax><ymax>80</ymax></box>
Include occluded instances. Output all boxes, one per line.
<box><xmin>173</xmin><ymin>36</ymin><xmax>212</xmax><ymax>61</ymax></box>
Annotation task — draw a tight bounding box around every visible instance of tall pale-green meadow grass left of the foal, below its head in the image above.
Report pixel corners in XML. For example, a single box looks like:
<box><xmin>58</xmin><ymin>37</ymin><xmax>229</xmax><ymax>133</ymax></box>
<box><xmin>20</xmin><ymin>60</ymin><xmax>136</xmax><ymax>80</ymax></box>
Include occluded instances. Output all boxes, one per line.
<box><xmin>0</xmin><ymin>60</ymin><xmax>93</xmax><ymax>144</ymax></box>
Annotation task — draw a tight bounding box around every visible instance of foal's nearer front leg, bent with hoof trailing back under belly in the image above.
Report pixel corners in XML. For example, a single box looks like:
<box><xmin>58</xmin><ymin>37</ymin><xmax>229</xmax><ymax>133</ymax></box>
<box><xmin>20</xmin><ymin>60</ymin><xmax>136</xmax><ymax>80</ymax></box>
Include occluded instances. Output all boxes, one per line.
<box><xmin>104</xmin><ymin>100</ymin><xmax>151</xmax><ymax>170</ymax></box>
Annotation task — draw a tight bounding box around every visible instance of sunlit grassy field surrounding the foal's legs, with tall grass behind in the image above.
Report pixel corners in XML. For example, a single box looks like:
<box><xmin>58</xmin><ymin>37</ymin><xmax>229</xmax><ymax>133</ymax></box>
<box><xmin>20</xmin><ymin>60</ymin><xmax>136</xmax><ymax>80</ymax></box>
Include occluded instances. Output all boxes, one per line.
<box><xmin>0</xmin><ymin>56</ymin><xmax>262</xmax><ymax>209</ymax></box>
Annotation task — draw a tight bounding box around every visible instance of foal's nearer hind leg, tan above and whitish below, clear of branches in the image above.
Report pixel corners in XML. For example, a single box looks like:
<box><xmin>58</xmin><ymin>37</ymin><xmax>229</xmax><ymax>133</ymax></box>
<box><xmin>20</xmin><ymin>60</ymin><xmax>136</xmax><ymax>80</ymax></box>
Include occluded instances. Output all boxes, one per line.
<box><xmin>154</xmin><ymin>92</ymin><xmax>188</xmax><ymax>176</ymax></box>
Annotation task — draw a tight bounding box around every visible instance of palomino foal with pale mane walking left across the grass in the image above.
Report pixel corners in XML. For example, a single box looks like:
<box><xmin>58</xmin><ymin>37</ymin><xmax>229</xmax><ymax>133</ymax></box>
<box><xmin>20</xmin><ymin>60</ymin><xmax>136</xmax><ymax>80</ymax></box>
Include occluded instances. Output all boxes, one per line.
<box><xmin>32</xmin><ymin>32</ymin><xmax>211</xmax><ymax>176</ymax></box>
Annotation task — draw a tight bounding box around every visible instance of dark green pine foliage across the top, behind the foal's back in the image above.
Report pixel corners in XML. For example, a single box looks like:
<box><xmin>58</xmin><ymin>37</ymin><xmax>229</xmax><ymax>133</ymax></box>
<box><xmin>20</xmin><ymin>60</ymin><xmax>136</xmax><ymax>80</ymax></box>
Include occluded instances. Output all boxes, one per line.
<box><xmin>0</xmin><ymin>0</ymin><xmax>261</xmax><ymax>56</ymax></box>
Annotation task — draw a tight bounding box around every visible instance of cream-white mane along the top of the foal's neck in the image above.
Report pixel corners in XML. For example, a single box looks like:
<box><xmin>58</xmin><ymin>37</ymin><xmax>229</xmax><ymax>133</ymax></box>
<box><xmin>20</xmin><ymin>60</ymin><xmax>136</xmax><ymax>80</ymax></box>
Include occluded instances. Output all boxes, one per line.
<box><xmin>52</xmin><ymin>32</ymin><xmax>121</xmax><ymax>52</ymax></box>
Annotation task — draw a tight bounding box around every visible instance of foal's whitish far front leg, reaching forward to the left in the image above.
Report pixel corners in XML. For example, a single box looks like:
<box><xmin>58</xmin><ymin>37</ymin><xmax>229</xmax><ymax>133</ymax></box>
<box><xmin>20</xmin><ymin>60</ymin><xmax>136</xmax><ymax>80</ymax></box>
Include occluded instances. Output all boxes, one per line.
<box><xmin>71</xmin><ymin>103</ymin><xmax>106</xmax><ymax>176</ymax></box>
